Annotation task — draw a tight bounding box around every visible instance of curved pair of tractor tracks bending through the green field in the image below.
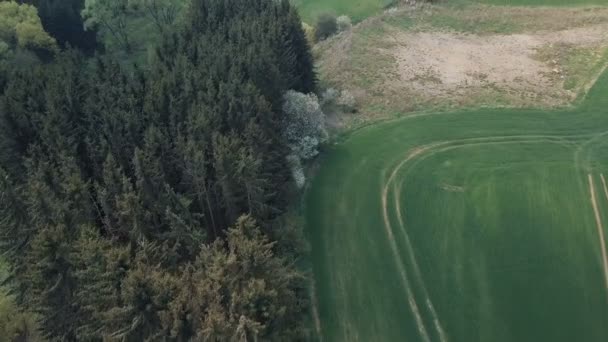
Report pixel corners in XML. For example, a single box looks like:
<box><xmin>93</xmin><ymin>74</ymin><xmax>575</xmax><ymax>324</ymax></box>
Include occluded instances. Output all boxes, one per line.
<box><xmin>381</xmin><ymin>135</ymin><xmax>587</xmax><ymax>342</ymax></box>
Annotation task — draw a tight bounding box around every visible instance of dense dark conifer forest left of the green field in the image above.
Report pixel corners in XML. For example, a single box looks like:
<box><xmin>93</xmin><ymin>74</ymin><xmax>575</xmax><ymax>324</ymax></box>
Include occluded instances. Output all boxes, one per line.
<box><xmin>0</xmin><ymin>0</ymin><xmax>316</xmax><ymax>341</ymax></box>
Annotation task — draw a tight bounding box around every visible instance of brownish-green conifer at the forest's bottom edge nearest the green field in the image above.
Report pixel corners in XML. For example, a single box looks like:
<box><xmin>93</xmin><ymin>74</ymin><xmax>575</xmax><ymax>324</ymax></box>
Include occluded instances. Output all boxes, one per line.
<box><xmin>177</xmin><ymin>216</ymin><xmax>304</xmax><ymax>341</ymax></box>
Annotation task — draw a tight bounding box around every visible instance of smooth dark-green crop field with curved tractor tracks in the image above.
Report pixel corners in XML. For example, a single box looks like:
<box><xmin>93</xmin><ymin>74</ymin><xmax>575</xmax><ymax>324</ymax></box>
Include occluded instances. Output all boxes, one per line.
<box><xmin>306</xmin><ymin>65</ymin><xmax>608</xmax><ymax>342</ymax></box>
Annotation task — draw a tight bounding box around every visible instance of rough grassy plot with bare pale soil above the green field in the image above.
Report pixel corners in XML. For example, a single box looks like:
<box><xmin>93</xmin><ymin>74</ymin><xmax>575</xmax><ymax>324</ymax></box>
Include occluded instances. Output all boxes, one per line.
<box><xmin>316</xmin><ymin>2</ymin><xmax>608</xmax><ymax>125</ymax></box>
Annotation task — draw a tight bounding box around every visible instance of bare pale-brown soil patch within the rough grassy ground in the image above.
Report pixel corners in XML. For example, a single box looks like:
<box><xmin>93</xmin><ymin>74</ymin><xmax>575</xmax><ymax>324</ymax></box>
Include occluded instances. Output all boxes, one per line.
<box><xmin>387</xmin><ymin>24</ymin><xmax>608</xmax><ymax>106</ymax></box>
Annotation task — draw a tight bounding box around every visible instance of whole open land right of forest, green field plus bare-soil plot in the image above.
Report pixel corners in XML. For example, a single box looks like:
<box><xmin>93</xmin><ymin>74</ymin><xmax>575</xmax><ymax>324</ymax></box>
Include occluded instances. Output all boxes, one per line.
<box><xmin>305</xmin><ymin>0</ymin><xmax>608</xmax><ymax>342</ymax></box>
